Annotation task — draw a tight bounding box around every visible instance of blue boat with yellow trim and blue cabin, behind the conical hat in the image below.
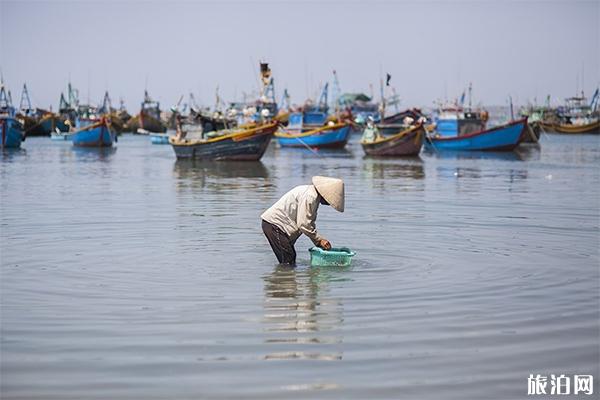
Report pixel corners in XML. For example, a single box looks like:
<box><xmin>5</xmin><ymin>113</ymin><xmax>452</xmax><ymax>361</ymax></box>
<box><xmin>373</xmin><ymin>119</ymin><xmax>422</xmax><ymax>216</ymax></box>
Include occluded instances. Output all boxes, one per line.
<box><xmin>275</xmin><ymin>111</ymin><xmax>350</xmax><ymax>148</ymax></box>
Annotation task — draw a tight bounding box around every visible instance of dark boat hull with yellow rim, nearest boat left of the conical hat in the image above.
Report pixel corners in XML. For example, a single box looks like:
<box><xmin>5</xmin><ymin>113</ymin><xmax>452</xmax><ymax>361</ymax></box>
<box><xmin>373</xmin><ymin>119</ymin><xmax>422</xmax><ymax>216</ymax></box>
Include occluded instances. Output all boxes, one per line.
<box><xmin>169</xmin><ymin>122</ymin><xmax>279</xmax><ymax>161</ymax></box>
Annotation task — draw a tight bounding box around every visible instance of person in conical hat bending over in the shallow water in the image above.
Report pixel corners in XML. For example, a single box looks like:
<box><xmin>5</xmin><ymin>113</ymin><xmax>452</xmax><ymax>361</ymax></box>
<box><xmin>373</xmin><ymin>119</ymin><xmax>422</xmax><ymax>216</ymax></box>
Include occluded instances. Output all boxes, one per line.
<box><xmin>260</xmin><ymin>176</ymin><xmax>344</xmax><ymax>265</ymax></box>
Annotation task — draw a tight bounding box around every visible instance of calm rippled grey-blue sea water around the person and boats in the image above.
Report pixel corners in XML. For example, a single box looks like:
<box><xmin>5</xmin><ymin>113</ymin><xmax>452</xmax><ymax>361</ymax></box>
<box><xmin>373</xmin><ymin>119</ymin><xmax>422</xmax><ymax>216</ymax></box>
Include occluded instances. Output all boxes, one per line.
<box><xmin>0</xmin><ymin>135</ymin><xmax>600</xmax><ymax>399</ymax></box>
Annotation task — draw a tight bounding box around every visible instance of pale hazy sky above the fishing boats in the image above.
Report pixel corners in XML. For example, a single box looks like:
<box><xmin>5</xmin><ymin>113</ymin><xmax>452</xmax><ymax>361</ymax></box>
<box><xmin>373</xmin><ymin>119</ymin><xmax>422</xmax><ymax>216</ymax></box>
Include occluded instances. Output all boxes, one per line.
<box><xmin>0</xmin><ymin>0</ymin><xmax>600</xmax><ymax>111</ymax></box>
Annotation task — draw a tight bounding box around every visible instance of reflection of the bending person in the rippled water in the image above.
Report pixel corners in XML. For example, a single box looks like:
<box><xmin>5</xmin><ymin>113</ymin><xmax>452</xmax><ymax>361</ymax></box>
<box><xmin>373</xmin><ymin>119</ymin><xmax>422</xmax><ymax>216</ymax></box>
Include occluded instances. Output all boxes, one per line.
<box><xmin>263</xmin><ymin>266</ymin><xmax>347</xmax><ymax>361</ymax></box>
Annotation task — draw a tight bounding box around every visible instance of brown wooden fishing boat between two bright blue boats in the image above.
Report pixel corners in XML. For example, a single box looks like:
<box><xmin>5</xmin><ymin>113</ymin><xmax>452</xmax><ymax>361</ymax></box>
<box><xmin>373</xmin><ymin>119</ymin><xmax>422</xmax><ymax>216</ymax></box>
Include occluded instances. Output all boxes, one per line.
<box><xmin>360</xmin><ymin>124</ymin><xmax>426</xmax><ymax>156</ymax></box>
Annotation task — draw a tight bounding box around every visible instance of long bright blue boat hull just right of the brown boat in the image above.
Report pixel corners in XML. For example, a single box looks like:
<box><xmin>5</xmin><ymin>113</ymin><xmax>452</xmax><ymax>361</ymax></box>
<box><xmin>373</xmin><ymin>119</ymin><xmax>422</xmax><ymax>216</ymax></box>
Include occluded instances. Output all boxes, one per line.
<box><xmin>425</xmin><ymin>118</ymin><xmax>527</xmax><ymax>151</ymax></box>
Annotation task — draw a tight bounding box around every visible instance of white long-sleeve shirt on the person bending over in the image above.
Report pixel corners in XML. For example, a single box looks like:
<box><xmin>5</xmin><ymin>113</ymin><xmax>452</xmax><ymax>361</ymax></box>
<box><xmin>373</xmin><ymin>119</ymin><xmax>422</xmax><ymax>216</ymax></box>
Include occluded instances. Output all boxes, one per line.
<box><xmin>260</xmin><ymin>185</ymin><xmax>323</xmax><ymax>245</ymax></box>
